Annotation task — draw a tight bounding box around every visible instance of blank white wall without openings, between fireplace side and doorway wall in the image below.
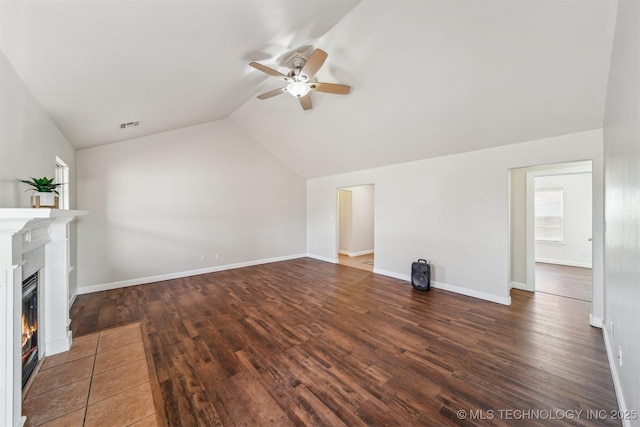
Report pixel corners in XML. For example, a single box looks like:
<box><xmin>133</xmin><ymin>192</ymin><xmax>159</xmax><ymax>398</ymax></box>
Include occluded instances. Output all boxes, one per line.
<box><xmin>78</xmin><ymin>120</ymin><xmax>305</xmax><ymax>293</ymax></box>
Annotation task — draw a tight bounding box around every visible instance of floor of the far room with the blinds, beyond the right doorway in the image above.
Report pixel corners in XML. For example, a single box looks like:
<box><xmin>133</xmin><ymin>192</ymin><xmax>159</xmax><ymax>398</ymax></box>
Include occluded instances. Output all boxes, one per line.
<box><xmin>536</xmin><ymin>262</ymin><xmax>592</xmax><ymax>301</ymax></box>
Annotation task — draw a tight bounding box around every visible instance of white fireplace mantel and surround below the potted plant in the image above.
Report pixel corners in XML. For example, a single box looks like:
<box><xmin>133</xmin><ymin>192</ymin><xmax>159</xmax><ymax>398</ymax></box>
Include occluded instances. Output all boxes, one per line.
<box><xmin>0</xmin><ymin>208</ymin><xmax>88</xmax><ymax>427</ymax></box>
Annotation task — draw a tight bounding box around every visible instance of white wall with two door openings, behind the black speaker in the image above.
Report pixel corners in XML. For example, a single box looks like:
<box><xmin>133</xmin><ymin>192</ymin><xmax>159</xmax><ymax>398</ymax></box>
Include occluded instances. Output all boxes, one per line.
<box><xmin>307</xmin><ymin>130</ymin><xmax>602</xmax><ymax>304</ymax></box>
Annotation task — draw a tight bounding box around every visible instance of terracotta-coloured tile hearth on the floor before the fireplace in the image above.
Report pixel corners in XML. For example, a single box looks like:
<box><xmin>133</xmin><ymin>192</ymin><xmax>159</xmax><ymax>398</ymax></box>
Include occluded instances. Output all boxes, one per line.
<box><xmin>22</xmin><ymin>323</ymin><xmax>158</xmax><ymax>427</ymax></box>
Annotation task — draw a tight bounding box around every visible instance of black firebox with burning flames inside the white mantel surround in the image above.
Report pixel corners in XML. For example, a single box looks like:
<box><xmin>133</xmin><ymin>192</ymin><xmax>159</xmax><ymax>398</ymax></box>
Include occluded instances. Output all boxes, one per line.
<box><xmin>22</xmin><ymin>271</ymin><xmax>38</xmax><ymax>388</ymax></box>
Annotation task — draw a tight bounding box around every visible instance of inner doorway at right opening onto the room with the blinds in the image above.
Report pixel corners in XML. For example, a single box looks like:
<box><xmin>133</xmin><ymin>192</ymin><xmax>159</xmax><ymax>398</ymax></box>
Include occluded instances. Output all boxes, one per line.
<box><xmin>534</xmin><ymin>172</ymin><xmax>593</xmax><ymax>301</ymax></box>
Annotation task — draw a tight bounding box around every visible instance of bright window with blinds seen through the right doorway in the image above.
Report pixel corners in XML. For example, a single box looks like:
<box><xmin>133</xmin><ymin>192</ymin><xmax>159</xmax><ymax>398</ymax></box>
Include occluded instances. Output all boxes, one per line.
<box><xmin>536</xmin><ymin>188</ymin><xmax>562</xmax><ymax>242</ymax></box>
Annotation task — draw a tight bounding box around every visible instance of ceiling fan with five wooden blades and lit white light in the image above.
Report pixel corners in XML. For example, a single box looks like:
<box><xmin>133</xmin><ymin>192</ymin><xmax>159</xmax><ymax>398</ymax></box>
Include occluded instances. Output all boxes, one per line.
<box><xmin>249</xmin><ymin>49</ymin><xmax>351</xmax><ymax>110</ymax></box>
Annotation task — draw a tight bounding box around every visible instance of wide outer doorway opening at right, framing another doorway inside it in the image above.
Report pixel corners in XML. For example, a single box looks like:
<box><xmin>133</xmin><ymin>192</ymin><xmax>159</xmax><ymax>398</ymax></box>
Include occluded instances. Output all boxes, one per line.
<box><xmin>509</xmin><ymin>160</ymin><xmax>603</xmax><ymax>308</ymax></box>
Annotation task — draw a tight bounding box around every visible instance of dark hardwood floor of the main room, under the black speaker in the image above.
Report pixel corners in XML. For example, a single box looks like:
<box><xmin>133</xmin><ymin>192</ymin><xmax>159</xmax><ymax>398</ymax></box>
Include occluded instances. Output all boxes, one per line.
<box><xmin>71</xmin><ymin>258</ymin><xmax>620</xmax><ymax>426</ymax></box>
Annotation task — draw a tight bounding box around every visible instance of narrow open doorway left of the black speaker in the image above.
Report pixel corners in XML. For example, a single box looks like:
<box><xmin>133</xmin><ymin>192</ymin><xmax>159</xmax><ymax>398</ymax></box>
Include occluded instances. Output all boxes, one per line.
<box><xmin>338</xmin><ymin>184</ymin><xmax>375</xmax><ymax>271</ymax></box>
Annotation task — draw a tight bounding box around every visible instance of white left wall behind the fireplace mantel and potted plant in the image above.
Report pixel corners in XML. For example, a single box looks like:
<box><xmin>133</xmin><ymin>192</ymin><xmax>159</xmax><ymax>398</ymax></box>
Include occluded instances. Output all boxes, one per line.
<box><xmin>0</xmin><ymin>51</ymin><xmax>77</xmax><ymax>295</ymax></box>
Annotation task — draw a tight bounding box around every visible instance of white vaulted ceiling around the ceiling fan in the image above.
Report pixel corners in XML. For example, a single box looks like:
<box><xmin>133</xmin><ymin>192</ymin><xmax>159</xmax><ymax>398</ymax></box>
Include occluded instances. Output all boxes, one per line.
<box><xmin>0</xmin><ymin>0</ymin><xmax>617</xmax><ymax>177</ymax></box>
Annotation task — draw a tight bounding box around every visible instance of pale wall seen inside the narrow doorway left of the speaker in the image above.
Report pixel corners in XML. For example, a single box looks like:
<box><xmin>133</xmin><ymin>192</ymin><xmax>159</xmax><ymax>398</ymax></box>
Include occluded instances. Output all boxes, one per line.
<box><xmin>338</xmin><ymin>185</ymin><xmax>374</xmax><ymax>256</ymax></box>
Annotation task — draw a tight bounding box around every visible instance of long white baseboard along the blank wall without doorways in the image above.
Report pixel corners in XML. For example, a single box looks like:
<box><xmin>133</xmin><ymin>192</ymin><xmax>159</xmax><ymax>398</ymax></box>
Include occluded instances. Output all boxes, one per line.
<box><xmin>77</xmin><ymin>254</ymin><xmax>307</xmax><ymax>295</ymax></box>
